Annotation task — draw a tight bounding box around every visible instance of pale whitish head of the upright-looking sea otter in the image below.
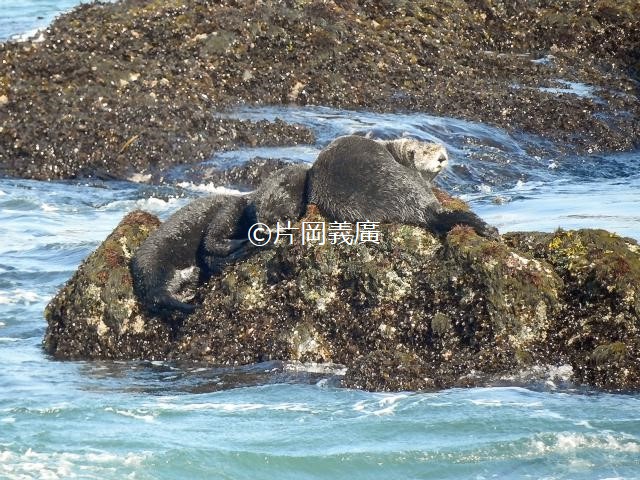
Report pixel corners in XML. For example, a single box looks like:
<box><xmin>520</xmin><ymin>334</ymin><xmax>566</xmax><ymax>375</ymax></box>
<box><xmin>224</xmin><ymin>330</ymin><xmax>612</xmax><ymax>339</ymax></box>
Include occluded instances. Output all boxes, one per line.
<box><xmin>386</xmin><ymin>138</ymin><xmax>449</xmax><ymax>181</ymax></box>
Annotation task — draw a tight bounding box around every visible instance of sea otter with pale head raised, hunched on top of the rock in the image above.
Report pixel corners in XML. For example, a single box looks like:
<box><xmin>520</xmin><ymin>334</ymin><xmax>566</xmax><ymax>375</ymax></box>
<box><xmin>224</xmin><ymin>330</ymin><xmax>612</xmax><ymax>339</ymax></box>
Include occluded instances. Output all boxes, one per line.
<box><xmin>308</xmin><ymin>135</ymin><xmax>497</xmax><ymax>236</ymax></box>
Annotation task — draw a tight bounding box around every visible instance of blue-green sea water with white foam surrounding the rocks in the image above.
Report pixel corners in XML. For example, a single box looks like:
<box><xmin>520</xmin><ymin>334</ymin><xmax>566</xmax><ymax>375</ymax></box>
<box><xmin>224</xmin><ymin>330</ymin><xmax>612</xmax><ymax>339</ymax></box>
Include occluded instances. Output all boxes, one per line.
<box><xmin>0</xmin><ymin>4</ymin><xmax>640</xmax><ymax>480</ymax></box>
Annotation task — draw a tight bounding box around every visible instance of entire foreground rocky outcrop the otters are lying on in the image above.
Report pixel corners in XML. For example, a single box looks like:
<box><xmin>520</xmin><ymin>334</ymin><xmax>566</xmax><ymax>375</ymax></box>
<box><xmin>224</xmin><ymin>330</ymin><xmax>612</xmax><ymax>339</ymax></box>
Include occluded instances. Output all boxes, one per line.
<box><xmin>45</xmin><ymin>201</ymin><xmax>640</xmax><ymax>390</ymax></box>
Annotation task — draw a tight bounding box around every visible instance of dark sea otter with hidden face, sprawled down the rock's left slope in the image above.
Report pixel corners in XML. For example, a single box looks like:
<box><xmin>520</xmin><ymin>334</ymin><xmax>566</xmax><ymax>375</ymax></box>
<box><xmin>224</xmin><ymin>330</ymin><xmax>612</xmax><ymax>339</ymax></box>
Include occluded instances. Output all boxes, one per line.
<box><xmin>131</xmin><ymin>165</ymin><xmax>309</xmax><ymax>317</ymax></box>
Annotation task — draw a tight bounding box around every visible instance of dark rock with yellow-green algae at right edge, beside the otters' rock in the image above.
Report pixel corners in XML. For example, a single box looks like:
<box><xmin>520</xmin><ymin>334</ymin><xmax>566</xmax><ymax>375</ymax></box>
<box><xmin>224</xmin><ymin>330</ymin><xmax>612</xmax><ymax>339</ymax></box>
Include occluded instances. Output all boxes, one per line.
<box><xmin>505</xmin><ymin>230</ymin><xmax>640</xmax><ymax>389</ymax></box>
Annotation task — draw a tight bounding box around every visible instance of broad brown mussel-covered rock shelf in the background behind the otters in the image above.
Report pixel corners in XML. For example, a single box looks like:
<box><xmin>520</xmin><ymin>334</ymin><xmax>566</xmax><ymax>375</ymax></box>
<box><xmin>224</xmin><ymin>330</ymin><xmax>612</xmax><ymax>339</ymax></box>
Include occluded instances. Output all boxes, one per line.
<box><xmin>0</xmin><ymin>0</ymin><xmax>640</xmax><ymax>180</ymax></box>
